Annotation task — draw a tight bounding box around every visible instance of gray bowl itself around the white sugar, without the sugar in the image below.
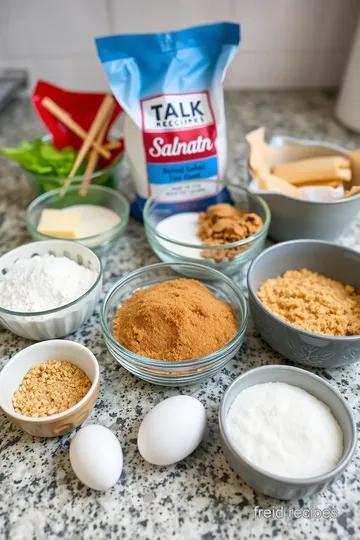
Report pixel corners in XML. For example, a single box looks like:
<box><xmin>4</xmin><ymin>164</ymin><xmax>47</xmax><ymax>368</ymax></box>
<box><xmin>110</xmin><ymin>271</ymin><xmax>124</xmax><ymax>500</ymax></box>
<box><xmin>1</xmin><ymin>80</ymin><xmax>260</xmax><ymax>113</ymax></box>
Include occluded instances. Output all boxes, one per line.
<box><xmin>219</xmin><ymin>366</ymin><xmax>357</xmax><ymax>500</ymax></box>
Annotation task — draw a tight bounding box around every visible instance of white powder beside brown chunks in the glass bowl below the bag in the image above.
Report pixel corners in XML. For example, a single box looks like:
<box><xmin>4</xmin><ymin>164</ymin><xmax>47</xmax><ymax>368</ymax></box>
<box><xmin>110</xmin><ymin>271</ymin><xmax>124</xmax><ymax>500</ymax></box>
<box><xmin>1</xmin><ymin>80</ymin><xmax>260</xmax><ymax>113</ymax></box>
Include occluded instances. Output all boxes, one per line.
<box><xmin>156</xmin><ymin>212</ymin><xmax>202</xmax><ymax>259</ymax></box>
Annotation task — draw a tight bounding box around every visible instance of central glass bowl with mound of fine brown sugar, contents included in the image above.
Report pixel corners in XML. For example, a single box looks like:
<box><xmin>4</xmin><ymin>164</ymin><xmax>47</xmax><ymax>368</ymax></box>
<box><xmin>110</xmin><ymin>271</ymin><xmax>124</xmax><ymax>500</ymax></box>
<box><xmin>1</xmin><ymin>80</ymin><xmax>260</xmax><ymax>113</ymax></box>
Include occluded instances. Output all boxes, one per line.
<box><xmin>100</xmin><ymin>263</ymin><xmax>248</xmax><ymax>386</ymax></box>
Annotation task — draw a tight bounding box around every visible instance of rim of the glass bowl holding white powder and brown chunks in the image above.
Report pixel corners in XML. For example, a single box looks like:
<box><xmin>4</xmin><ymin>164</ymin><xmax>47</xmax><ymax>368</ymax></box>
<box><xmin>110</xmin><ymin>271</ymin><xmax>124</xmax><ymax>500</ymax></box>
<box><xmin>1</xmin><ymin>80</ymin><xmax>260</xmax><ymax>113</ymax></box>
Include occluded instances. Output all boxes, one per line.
<box><xmin>143</xmin><ymin>178</ymin><xmax>271</xmax><ymax>251</ymax></box>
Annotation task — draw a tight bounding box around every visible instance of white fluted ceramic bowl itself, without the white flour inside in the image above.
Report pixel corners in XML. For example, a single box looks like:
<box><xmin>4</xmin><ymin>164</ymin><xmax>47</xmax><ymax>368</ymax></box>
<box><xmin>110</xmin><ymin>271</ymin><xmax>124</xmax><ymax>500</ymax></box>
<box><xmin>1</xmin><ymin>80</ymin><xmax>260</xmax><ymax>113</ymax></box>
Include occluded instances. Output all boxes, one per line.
<box><xmin>0</xmin><ymin>240</ymin><xmax>103</xmax><ymax>341</ymax></box>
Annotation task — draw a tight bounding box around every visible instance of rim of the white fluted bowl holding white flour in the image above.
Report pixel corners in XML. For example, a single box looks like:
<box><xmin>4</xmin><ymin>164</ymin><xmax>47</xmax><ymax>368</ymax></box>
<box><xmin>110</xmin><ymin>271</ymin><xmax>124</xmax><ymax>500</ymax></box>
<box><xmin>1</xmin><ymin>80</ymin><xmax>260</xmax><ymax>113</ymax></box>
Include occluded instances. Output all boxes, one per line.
<box><xmin>0</xmin><ymin>239</ymin><xmax>103</xmax><ymax>317</ymax></box>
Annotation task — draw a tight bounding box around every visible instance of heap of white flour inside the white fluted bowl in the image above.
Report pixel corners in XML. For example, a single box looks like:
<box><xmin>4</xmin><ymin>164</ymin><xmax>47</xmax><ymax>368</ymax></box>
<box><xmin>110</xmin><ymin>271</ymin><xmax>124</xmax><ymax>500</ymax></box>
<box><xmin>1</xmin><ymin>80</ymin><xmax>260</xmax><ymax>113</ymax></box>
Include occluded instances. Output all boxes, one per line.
<box><xmin>0</xmin><ymin>254</ymin><xmax>97</xmax><ymax>313</ymax></box>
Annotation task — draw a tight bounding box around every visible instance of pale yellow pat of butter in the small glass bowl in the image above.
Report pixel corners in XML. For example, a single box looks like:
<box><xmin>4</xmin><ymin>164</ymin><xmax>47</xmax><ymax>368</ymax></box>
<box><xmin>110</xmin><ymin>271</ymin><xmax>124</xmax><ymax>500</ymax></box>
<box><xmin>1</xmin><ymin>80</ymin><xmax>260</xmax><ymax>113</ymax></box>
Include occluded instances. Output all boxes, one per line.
<box><xmin>37</xmin><ymin>208</ymin><xmax>81</xmax><ymax>238</ymax></box>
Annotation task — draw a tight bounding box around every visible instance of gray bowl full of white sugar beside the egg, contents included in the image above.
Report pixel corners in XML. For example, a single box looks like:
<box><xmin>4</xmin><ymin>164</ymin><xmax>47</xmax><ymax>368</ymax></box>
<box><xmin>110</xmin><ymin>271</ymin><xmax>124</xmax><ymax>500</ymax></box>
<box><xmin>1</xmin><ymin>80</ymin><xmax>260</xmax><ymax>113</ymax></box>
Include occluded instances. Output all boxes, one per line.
<box><xmin>219</xmin><ymin>365</ymin><xmax>357</xmax><ymax>499</ymax></box>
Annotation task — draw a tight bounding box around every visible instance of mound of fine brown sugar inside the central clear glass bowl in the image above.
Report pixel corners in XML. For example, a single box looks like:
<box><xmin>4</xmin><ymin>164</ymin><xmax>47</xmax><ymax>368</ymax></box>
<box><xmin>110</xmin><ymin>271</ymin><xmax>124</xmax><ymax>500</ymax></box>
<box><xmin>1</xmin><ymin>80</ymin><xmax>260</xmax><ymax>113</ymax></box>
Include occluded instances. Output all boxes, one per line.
<box><xmin>113</xmin><ymin>278</ymin><xmax>237</xmax><ymax>362</ymax></box>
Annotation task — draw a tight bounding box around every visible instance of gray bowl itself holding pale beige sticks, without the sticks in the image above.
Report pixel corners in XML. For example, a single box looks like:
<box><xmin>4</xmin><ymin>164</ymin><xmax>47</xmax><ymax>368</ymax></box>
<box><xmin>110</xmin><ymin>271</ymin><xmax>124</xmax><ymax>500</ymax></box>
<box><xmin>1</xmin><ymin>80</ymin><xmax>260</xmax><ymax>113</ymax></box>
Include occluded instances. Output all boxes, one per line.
<box><xmin>248</xmin><ymin>136</ymin><xmax>360</xmax><ymax>242</ymax></box>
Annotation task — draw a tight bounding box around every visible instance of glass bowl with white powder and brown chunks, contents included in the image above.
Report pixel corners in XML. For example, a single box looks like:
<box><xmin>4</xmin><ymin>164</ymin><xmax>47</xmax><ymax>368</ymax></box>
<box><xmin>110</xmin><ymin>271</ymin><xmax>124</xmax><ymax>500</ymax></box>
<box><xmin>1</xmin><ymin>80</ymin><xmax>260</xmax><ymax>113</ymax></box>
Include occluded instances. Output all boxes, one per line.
<box><xmin>143</xmin><ymin>180</ymin><xmax>270</xmax><ymax>275</ymax></box>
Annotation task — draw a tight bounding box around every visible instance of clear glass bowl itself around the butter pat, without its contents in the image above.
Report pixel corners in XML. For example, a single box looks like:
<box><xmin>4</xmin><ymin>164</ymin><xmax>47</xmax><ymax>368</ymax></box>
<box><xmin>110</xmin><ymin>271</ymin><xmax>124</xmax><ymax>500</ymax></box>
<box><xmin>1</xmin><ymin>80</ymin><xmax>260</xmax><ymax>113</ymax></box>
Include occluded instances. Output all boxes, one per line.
<box><xmin>25</xmin><ymin>185</ymin><xmax>130</xmax><ymax>257</ymax></box>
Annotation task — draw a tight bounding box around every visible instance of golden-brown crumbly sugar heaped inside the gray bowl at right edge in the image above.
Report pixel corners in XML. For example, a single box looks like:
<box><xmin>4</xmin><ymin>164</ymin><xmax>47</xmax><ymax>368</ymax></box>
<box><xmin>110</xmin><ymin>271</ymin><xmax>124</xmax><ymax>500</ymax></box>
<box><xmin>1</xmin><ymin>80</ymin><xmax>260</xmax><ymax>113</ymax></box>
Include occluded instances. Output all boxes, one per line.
<box><xmin>258</xmin><ymin>269</ymin><xmax>360</xmax><ymax>336</ymax></box>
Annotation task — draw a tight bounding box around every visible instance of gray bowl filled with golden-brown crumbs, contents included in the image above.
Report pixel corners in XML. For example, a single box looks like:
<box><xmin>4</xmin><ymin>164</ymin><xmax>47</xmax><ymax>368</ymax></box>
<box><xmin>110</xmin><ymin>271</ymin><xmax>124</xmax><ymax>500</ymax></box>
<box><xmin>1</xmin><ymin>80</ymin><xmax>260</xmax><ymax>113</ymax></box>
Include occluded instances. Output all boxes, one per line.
<box><xmin>248</xmin><ymin>240</ymin><xmax>360</xmax><ymax>368</ymax></box>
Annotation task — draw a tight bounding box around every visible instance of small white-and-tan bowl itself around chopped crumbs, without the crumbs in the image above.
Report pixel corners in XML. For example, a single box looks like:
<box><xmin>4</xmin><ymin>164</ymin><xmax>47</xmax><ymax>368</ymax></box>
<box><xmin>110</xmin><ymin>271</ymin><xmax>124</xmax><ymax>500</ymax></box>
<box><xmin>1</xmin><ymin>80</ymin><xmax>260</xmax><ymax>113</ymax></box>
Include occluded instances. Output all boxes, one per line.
<box><xmin>0</xmin><ymin>339</ymin><xmax>99</xmax><ymax>437</ymax></box>
